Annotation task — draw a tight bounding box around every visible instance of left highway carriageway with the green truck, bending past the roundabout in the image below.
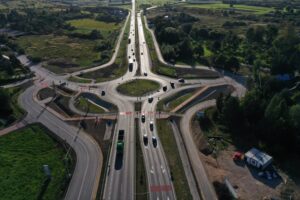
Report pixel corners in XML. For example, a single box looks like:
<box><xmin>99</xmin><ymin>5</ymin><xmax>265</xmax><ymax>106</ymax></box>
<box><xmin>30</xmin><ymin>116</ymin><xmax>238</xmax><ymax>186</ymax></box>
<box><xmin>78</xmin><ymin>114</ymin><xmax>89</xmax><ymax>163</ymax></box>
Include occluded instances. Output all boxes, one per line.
<box><xmin>103</xmin><ymin>0</ymin><xmax>138</xmax><ymax>199</ymax></box>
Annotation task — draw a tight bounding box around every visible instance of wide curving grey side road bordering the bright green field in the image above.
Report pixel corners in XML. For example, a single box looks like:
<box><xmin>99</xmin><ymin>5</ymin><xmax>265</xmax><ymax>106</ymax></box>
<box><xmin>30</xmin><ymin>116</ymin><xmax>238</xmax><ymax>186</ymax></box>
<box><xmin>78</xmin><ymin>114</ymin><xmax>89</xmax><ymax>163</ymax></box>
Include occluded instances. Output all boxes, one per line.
<box><xmin>19</xmin><ymin>86</ymin><xmax>103</xmax><ymax>200</ymax></box>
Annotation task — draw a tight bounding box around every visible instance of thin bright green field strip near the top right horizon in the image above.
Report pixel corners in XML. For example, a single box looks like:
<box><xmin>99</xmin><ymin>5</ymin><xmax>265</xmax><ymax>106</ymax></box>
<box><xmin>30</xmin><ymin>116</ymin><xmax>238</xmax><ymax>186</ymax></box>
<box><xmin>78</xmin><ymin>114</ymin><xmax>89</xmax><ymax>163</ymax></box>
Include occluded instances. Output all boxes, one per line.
<box><xmin>184</xmin><ymin>3</ymin><xmax>274</xmax><ymax>14</ymax></box>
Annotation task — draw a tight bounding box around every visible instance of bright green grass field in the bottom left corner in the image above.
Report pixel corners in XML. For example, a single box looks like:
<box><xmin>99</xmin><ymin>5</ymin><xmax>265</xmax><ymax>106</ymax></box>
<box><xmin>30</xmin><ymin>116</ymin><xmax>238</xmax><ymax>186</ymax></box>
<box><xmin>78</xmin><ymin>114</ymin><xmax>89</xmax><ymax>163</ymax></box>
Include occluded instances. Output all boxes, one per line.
<box><xmin>0</xmin><ymin>124</ymin><xmax>73</xmax><ymax>200</ymax></box>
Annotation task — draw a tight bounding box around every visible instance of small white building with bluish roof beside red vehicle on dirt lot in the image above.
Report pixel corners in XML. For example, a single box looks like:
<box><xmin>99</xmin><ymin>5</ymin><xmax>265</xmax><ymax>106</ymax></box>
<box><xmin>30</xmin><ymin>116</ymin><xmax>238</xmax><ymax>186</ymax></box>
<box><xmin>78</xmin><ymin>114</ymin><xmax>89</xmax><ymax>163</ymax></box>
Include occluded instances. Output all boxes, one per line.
<box><xmin>245</xmin><ymin>148</ymin><xmax>273</xmax><ymax>169</ymax></box>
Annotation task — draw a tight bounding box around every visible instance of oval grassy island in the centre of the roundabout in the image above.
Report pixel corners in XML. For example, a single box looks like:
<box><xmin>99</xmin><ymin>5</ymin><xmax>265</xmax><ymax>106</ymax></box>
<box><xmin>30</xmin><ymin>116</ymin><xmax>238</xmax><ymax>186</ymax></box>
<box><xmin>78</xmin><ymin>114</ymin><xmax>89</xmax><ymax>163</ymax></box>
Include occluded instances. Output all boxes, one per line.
<box><xmin>117</xmin><ymin>79</ymin><xmax>160</xmax><ymax>96</ymax></box>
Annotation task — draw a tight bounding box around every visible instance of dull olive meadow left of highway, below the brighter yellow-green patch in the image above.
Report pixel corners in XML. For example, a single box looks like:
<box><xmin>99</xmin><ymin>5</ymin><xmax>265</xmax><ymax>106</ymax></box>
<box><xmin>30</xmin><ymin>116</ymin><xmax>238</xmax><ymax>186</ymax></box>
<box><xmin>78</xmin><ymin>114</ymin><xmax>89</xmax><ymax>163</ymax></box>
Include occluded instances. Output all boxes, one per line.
<box><xmin>17</xmin><ymin>35</ymin><xmax>100</xmax><ymax>73</ymax></box>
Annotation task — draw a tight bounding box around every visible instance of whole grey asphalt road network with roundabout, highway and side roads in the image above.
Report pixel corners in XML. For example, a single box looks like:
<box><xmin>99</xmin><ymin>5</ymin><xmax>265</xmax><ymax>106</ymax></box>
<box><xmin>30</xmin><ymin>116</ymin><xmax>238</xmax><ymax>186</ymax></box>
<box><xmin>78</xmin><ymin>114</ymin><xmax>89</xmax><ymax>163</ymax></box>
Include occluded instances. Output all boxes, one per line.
<box><xmin>5</xmin><ymin>0</ymin><xmax>246</xmax><ymax>200</ymax></box>
